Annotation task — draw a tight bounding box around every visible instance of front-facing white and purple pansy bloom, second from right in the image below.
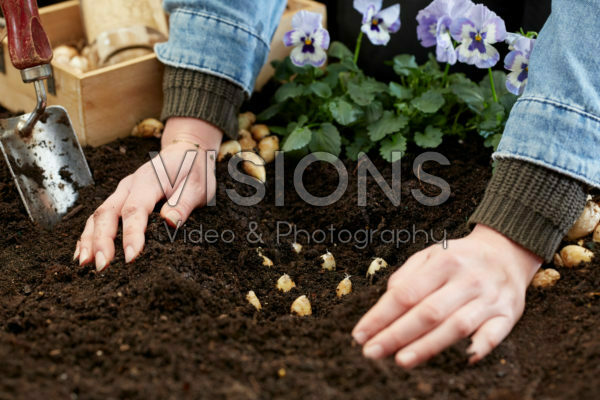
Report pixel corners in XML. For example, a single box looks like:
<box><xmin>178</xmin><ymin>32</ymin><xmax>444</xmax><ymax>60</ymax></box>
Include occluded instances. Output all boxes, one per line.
<box><xmin>450</xmin><ymin>4</ymin><xmax>506</xmax><ymax>68</ymax></box>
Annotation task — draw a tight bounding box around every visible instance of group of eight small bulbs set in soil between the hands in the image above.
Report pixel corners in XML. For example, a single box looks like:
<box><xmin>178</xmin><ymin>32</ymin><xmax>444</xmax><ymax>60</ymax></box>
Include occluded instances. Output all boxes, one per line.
<box><xmin>246</xmin><ymin>243</ymin><xmax>388</xmax><ymax>317</ymax></box>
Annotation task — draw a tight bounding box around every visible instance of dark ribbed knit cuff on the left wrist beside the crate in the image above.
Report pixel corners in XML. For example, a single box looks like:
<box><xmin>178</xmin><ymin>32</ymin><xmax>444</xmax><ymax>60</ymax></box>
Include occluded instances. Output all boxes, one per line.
<box><xmin>161</xmin><ymin>66</ymin><xmax>245</xmax><ymax>139</ymax></box>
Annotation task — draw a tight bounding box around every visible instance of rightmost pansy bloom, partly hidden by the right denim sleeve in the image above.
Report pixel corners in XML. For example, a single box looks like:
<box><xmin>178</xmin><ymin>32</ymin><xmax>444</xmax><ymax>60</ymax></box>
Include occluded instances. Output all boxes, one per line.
<box><xmin>504</xmin><ymin>34</ymin><xmax>535</xmax><ymax>96</ymax></box>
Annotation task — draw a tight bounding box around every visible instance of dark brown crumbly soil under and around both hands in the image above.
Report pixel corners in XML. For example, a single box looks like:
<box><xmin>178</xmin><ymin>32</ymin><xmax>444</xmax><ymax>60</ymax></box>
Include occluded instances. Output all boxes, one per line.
<box><xmin>0</xmin><ymin>139</ymin><xmax>600</xmax><ymax>400</ymax></box>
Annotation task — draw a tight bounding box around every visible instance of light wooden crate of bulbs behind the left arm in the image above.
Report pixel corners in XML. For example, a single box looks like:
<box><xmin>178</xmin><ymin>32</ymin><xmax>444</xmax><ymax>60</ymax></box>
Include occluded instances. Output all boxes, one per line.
<box><xmin>0</xmin><ymin>0</ymin><xmax>326</xmax><ymax>146</ymax></box>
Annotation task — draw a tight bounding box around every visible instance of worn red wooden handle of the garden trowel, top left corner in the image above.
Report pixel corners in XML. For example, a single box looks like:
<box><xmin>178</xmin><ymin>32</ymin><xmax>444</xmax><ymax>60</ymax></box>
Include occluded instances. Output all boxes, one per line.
<box><xmin>0</xmin><ymin>0</ymin><xmax>52</xmax><ymax>69</ymax></box>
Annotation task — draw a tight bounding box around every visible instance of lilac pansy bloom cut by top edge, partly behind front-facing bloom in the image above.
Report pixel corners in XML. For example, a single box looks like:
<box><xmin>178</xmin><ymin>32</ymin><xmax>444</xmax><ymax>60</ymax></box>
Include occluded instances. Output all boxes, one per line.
<box><xmin>417</xmin><ymin>0</ymin><xmax>475</xmax><ymax>65</ymax></box>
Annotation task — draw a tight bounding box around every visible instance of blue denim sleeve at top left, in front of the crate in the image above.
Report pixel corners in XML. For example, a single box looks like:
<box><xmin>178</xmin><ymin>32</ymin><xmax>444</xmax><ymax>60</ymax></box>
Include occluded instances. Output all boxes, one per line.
<box><xmin>155</xmin><ymin>0</ymin><xmax>286</xmax><ymax>95</ymax></box>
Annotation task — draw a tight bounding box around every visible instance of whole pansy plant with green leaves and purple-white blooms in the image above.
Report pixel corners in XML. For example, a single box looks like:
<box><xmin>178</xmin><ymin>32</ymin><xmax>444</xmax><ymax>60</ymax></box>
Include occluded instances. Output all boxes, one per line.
<box><xmin>258</xmin><ymin>0</ymin><xmax>535</xmax><ymax>162</ymax></box>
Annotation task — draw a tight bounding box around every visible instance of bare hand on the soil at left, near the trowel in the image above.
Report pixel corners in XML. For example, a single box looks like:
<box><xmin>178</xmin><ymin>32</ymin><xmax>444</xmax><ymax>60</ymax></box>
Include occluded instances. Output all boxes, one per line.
<box><xmin>74</xmin><ymin>118</ymin><xmax>222</xmax><ymax>271</ymax></box>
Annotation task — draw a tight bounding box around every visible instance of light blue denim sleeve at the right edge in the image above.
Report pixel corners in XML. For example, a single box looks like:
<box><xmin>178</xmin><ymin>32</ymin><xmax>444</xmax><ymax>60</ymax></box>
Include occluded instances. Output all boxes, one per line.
<box><xmin>494</xmin><ymin>0</ymin><xmax>600</xmax><ymax>187</ymax></box>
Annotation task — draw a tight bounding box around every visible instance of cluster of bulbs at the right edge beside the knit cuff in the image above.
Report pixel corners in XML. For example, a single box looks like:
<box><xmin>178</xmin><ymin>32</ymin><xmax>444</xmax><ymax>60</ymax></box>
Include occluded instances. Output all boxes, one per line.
<box><xmin>532</xmin><ymin>197</ymin><xmax>600</xmax><ymax>287</ymax></box>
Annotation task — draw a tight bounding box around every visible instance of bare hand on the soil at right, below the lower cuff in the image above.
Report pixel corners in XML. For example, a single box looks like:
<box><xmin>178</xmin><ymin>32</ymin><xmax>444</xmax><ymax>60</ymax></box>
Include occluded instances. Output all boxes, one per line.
<box><xmin>352</xmin><ymin>225</ymin><xmax>542</xmax><ymax>368</ymax></box>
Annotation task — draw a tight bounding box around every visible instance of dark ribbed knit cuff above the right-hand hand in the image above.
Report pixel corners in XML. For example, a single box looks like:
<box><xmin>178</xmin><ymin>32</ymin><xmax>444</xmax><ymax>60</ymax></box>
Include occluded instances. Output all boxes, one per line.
<box><xmin>469</xmin><ymin>159</ymin><xmax>586</xmax><ymax>262</ymax></box>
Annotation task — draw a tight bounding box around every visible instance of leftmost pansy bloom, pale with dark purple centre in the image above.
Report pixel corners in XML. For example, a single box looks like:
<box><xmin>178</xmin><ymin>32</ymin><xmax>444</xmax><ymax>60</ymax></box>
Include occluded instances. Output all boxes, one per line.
<box><xmin>283</xmin><ymin>10</ymin><xmax>329</xmax><ymax>67</ymax></box>
